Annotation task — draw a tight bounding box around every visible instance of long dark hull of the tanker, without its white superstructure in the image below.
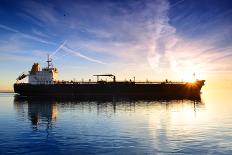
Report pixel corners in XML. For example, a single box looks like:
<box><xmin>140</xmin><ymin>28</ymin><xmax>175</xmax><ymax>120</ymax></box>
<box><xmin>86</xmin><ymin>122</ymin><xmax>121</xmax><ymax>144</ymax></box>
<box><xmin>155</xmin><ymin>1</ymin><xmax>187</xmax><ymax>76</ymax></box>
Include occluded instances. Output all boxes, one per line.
<box><xmin>14</xmin><ymin>80</ymin><xmax>205</xmax><ymax>99</ymax></box>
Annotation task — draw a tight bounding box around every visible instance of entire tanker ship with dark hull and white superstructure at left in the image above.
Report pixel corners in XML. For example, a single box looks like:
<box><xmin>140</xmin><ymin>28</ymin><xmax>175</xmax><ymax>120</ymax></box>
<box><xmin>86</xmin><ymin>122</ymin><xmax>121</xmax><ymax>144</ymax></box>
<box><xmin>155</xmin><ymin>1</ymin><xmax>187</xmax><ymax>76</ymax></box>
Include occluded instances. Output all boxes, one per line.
<box><xmin>14</xmin><ymin>56</ymin><xmax>205</xmax><ymax>99</ymax></box>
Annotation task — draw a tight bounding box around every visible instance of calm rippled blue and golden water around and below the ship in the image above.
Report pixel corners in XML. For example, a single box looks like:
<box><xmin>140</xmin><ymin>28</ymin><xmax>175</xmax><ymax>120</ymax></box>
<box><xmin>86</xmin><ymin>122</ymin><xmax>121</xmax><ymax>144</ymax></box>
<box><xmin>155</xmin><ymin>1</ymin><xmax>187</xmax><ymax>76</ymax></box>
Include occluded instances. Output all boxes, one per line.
<box><xmin>0</xmin><ymin>88</ymin><xmax>232</xmax><ymax>154</ymax></box>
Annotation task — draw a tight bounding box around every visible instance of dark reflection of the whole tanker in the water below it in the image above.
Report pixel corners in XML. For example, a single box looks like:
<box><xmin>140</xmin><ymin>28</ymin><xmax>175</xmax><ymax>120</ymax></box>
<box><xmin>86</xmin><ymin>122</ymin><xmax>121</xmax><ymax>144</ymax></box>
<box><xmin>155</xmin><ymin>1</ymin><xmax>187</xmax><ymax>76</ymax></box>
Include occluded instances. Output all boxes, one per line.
<box><xmin>14</xmin><ymin>95</ymin><xmax>204</xmax><ymax>129</ymax></box>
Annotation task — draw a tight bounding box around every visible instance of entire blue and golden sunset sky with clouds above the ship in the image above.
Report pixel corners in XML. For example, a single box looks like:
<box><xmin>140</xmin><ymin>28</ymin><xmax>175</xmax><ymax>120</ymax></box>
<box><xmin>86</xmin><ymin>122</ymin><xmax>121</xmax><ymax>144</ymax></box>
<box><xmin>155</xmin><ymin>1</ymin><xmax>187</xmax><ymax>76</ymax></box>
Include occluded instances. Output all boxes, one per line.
<box><xmin>0</xmin><ymin>0</ymin><xmax>232</xmax><ymax>90</ymax></box>
